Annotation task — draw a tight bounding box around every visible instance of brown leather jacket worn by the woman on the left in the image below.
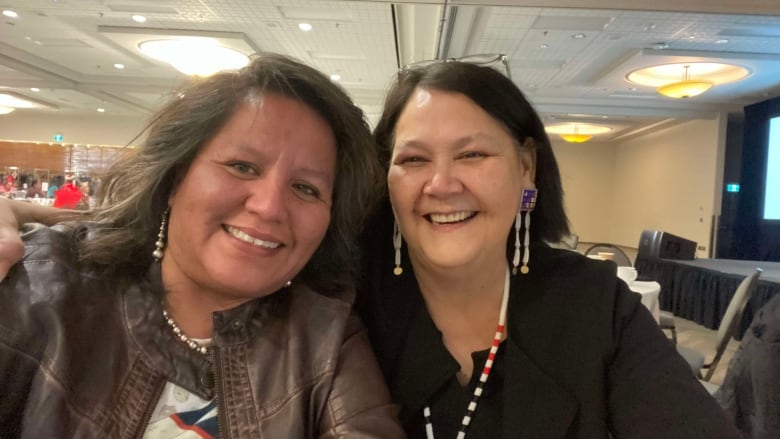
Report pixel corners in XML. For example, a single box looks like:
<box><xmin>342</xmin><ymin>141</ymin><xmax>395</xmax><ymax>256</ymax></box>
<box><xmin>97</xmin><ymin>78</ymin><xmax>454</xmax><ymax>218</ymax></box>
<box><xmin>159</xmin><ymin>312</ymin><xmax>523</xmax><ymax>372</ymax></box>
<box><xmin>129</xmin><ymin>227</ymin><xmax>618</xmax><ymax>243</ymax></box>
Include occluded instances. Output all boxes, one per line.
<box><xmin>0</xmin><ymin>225</ymin><xmax>403</xmax><ymax>439</ymax></box>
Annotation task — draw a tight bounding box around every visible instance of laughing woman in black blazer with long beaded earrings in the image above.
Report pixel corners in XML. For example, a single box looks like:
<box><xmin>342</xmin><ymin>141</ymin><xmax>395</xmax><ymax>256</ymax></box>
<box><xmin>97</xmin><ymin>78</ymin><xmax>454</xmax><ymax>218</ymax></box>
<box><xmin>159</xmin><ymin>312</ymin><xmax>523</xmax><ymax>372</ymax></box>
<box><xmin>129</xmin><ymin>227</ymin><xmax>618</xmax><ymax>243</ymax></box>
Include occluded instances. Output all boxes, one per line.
<box><xmin>357</xmin><ymin>62</ymin><xmax>739</xmax><ymax>439</ymax></box>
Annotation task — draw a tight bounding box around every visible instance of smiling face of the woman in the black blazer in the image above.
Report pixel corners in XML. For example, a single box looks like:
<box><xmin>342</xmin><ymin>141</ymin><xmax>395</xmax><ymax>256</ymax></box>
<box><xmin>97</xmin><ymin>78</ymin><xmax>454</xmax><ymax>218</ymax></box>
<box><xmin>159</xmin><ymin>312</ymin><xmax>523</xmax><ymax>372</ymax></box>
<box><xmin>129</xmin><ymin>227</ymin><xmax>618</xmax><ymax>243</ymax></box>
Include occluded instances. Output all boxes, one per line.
<box><xmin>387</xmin><ymin>88</ymin><xmax>534</xmax><ymax>269</ymax></box>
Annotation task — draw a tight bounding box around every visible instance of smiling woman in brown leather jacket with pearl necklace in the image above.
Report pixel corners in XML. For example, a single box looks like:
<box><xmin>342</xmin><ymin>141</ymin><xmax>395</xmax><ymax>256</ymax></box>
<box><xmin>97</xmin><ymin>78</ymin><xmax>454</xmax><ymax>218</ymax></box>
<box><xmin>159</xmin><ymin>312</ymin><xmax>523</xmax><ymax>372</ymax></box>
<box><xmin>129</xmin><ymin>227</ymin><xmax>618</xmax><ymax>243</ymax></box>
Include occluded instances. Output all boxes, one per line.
<box><xmin>0</xmin><ymin>54</ymin><xmax>403</xmax><ymax>439</ymax></box>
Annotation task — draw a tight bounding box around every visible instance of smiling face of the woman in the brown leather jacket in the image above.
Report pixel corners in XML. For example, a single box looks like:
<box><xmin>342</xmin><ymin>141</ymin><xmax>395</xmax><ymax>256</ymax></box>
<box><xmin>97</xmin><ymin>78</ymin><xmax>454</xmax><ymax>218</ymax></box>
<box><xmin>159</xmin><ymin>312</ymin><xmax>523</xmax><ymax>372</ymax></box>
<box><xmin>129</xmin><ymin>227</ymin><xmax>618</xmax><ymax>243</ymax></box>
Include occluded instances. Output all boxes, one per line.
<box><xmin>162</xmin><ymin>93</ymin><xmax>336</xmax><ymax>306</ymax></box>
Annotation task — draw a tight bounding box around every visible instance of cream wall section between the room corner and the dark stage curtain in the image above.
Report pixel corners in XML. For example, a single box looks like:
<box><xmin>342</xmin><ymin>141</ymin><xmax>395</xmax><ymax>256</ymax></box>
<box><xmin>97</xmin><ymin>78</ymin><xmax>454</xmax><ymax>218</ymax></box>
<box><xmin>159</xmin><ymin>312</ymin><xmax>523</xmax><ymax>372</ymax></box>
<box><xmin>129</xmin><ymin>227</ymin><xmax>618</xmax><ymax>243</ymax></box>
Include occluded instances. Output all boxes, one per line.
<box><xmin>612</xmin><ymin>115</ymin><xmax>726</xmax><ymax>257</ymax></box>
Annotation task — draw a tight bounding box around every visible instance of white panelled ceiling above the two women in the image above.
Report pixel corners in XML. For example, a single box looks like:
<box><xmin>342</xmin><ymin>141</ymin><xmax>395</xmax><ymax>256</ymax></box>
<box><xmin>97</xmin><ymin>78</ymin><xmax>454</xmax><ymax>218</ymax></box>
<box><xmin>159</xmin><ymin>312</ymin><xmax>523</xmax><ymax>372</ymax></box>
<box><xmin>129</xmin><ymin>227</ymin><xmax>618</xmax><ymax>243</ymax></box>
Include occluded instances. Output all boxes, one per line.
<box><xmin>0</xmin><ymin>0</ymin><xmax>780</xmax><ymax>140</ymax></box>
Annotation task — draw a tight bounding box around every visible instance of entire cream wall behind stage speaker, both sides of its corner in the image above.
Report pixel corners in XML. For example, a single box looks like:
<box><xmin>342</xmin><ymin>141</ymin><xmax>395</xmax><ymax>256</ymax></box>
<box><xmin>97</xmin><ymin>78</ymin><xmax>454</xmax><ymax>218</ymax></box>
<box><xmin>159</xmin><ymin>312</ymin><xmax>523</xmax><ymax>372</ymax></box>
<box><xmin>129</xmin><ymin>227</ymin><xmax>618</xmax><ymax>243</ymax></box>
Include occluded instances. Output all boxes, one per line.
<box><xmin>556</xmin><ymin>115</ymin><xmax>726</xmax><ymax>257</ymax></box>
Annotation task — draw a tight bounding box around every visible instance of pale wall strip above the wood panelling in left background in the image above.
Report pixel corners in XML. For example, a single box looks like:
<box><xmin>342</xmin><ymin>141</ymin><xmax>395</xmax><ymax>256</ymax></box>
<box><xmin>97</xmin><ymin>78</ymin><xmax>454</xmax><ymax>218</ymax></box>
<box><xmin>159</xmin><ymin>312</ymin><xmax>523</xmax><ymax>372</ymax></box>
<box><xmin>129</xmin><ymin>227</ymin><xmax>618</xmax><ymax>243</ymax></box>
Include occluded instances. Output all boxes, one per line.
<box><xmin>0</xmin><ymin>110</ymin><xmax>148</xmax><ymax>146</ymax></box>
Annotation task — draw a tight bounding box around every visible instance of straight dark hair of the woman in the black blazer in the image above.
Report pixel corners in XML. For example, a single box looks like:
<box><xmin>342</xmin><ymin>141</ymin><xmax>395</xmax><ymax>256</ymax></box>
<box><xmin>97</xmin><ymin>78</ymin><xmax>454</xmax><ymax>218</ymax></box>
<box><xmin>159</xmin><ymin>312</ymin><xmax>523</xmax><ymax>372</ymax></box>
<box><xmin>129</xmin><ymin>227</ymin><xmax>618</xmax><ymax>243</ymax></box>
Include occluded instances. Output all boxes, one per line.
<box><xmin>374</xmin><ymin>61</ymin><xmax>569</xmax><ymax>242</ymax></box>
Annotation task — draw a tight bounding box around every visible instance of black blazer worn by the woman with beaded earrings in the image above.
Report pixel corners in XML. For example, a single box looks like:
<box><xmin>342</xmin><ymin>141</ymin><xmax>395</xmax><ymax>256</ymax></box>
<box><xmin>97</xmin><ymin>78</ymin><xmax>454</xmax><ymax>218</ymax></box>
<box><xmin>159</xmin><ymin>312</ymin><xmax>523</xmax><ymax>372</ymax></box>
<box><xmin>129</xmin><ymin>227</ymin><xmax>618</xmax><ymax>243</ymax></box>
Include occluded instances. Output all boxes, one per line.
<box><xmin>357</xmin><ymin>202</ymin><xmax>740</xmax><ymax>439</ymax></box>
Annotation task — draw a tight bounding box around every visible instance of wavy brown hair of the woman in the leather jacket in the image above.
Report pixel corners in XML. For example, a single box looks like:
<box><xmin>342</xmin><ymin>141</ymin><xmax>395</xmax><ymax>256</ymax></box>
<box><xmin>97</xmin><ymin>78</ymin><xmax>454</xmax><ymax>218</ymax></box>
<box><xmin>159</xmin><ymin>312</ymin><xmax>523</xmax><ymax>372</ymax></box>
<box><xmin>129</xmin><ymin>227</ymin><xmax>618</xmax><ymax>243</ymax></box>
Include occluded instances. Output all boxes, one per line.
<box><xmin>82</xmin><ymin>54</ymin><xmax>383</xmax><ymax>294</ymax></box>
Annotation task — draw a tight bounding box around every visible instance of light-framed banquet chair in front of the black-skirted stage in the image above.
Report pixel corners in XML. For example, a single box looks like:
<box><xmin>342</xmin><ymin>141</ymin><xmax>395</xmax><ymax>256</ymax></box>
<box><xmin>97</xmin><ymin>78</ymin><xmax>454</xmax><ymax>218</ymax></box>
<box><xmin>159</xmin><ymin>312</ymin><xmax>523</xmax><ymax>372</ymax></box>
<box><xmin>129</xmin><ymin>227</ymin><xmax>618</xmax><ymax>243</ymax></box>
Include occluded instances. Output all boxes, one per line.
<box><xmin>677</xmin><ymin>268</ymin><xmax>761</xmax><ymax>381</ymax></box>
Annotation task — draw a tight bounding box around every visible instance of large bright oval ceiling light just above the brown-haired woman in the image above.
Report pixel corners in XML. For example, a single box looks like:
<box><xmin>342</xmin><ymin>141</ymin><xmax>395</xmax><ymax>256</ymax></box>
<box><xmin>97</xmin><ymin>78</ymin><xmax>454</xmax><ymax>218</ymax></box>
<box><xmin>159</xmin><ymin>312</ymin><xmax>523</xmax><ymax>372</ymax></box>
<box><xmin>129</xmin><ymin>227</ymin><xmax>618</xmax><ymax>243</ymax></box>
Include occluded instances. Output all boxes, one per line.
<box><xmin>138</xmin><ymin>37</ymin><xmax>249</xmax><ymax>76</ymax></box>
